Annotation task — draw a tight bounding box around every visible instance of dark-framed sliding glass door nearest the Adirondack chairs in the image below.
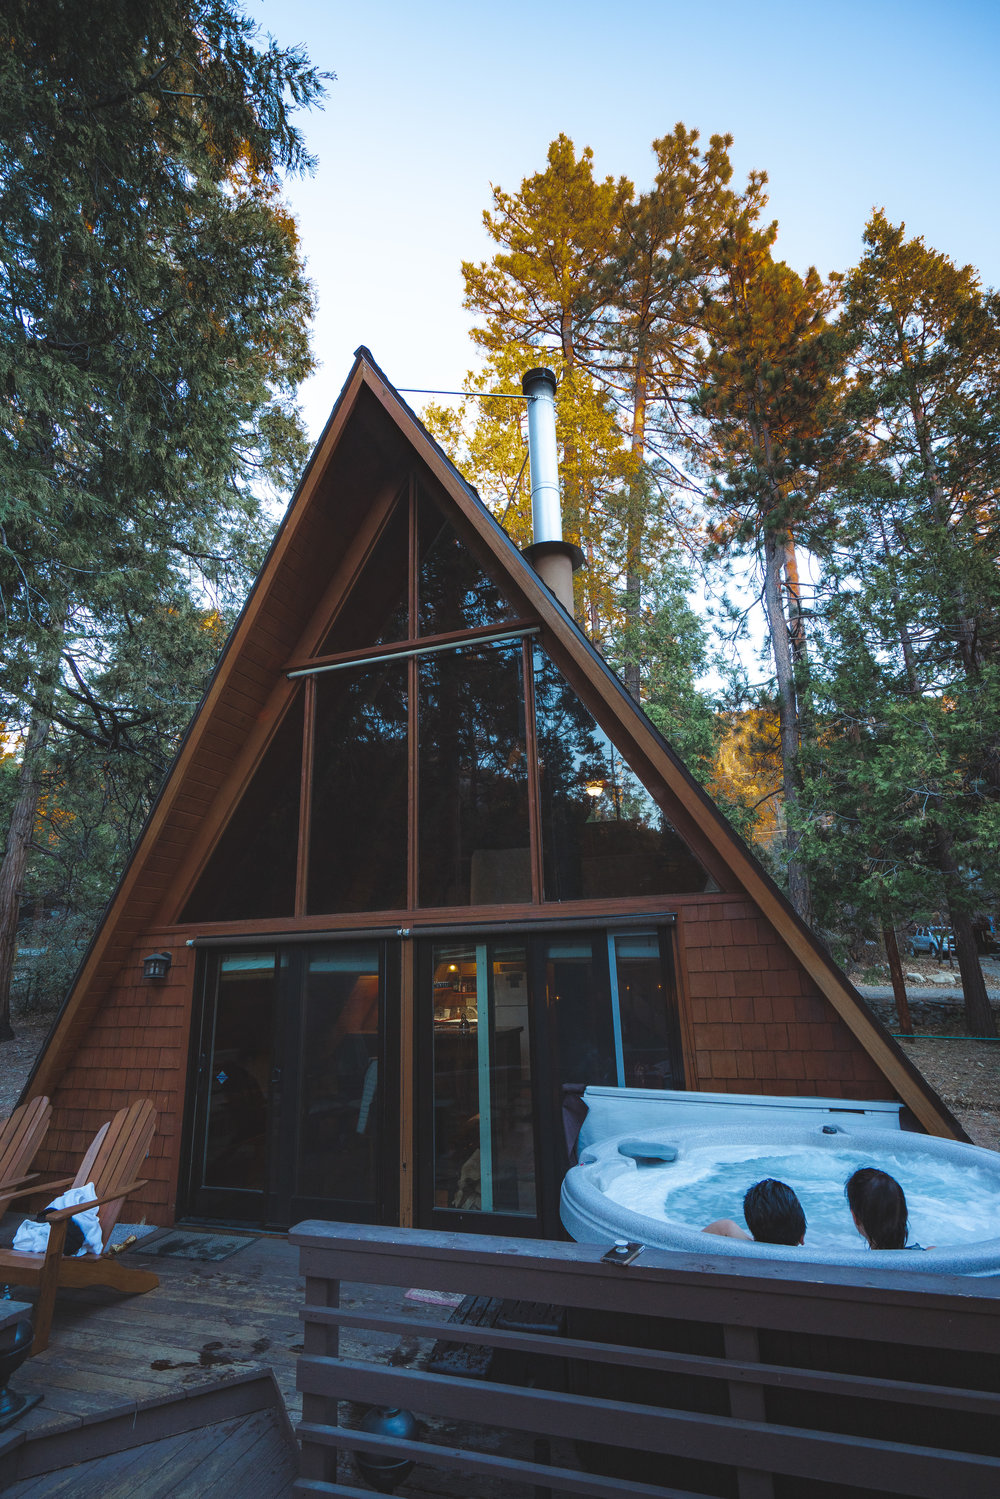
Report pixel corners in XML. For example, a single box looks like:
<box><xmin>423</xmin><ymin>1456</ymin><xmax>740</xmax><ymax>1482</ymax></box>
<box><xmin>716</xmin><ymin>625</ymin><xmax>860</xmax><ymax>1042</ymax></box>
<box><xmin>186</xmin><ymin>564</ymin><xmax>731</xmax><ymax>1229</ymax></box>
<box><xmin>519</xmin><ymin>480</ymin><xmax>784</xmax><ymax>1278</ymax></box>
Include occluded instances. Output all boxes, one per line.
<box><xmin>187</xmin><ymin>940</ymin><xmax>399</xmax><ymax>1228</ymax></box>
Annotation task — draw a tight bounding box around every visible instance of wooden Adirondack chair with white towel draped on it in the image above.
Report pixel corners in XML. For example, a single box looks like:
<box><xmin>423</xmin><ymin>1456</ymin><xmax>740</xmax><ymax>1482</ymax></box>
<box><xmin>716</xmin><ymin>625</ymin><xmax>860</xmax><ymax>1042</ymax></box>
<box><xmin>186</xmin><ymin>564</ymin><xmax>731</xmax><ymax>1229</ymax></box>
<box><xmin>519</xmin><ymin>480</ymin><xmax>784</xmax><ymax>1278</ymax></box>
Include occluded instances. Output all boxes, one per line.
<box><xmin>0</xmin><ymin>1099</ymin><xmax>159</xmax><ymax>1354</ymax></box>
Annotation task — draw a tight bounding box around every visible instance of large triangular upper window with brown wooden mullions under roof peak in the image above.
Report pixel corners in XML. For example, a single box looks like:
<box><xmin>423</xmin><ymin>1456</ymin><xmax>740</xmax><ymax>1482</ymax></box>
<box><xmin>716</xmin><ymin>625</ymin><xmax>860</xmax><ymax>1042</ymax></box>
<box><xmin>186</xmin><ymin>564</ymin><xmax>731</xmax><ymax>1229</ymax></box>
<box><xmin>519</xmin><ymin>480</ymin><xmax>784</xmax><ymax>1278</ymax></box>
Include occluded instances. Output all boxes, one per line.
<box><xmin>176</xmin><ymin>481</ymin><xmax>715</xmax><ymax>920</ymax></box>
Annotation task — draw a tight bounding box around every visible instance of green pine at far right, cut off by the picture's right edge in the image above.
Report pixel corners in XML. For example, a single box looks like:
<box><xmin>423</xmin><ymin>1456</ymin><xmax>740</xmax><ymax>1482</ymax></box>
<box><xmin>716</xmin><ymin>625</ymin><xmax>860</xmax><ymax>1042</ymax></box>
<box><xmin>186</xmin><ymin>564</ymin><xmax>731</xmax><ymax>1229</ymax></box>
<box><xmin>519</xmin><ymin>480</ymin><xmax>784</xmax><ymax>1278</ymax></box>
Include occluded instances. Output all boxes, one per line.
<box><xmin>815</xmin><ymin>213</ymin><xmax>1000</xmax><ymax>1034</ymax></box>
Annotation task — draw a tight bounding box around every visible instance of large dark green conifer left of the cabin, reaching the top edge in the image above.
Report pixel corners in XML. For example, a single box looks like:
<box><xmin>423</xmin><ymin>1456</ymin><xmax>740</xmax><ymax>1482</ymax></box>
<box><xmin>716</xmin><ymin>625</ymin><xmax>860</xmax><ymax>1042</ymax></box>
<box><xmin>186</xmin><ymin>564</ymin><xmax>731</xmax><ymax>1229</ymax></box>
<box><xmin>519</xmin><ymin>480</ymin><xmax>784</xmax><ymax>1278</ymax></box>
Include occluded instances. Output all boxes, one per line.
<box><xmin>0</xmin><ymin>0</ymin><xmax>322</xmax><ymax>1034</ymax></box>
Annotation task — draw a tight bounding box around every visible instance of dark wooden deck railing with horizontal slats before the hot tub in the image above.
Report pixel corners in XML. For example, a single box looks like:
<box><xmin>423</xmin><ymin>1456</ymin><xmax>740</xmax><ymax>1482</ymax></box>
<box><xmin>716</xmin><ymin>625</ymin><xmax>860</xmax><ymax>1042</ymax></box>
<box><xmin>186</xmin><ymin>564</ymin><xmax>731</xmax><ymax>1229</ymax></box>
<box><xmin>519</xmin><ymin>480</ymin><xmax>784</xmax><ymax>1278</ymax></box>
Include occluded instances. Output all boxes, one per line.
<box><xmin>291</xmin><ymin>1222</ymin><xmax>1000</xmax><ymax>1499</ymax></box>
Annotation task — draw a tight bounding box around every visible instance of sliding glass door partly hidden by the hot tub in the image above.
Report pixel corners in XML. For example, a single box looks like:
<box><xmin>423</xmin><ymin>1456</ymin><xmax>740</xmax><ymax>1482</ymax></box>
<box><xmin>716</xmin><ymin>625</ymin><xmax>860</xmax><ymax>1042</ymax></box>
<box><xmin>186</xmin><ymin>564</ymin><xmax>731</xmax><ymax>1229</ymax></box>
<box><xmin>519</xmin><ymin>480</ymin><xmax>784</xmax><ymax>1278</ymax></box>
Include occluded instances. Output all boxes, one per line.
<box><xmin>417</xmin><ymin>925</ymin><xmax>684</xmax><ymax>1237</ymax></box>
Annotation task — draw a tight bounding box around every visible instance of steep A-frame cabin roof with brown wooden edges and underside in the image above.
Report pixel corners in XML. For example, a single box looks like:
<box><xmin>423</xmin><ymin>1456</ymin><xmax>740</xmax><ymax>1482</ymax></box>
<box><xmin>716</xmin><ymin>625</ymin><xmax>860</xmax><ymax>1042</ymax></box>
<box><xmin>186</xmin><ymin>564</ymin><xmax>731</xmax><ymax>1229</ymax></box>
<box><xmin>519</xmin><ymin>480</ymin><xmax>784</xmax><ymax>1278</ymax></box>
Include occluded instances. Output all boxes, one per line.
<box><xmin>25</xmin><ymin>348</ymin><xmax>966</xmax><ymax>1139</ymax></box>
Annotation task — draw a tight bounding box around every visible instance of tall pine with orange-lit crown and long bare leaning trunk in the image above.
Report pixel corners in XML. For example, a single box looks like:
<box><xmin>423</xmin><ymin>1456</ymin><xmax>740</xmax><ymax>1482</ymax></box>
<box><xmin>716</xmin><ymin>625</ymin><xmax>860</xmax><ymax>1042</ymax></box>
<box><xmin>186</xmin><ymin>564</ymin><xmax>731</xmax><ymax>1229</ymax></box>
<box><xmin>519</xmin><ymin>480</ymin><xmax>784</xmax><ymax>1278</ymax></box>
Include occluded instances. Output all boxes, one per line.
<box><xmin>699</xmin><ymin>213</ymin><xmax>844</xmax><ymax>922</ymax></box>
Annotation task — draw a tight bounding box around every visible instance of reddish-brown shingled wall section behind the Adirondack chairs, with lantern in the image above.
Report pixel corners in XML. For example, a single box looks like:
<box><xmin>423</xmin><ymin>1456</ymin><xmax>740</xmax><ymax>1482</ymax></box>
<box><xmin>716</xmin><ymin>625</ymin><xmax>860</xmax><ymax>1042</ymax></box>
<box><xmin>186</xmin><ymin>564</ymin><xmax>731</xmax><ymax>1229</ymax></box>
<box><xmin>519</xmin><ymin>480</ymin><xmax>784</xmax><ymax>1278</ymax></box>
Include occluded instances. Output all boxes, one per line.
<box><xmin>36</xmin><ymin>928</ymin><xmax>195</xmax><ymax>1228</ymax></box>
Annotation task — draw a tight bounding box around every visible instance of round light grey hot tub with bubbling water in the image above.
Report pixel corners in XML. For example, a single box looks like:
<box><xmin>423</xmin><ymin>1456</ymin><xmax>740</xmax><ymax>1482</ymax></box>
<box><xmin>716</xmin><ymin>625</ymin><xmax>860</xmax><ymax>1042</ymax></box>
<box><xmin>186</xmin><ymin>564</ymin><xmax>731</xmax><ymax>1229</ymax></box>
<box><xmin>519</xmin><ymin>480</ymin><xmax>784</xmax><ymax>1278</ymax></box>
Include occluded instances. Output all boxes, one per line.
<box><xmin>561</xmin><ymin>1090</ymin><xmax>1000</xmax><ymax>1276</ymax></box>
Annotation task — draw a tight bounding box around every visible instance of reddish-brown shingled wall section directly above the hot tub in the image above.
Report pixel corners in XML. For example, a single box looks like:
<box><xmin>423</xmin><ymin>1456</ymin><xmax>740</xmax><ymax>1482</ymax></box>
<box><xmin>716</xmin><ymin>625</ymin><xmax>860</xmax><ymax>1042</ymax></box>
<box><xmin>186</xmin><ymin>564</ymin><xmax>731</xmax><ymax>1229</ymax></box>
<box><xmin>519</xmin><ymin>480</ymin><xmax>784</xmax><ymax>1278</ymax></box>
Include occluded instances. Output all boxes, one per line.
<box><xmin>678</xmin><ymin>896</ymin><xmax>897</xmax><ymax>1099</ymax></box>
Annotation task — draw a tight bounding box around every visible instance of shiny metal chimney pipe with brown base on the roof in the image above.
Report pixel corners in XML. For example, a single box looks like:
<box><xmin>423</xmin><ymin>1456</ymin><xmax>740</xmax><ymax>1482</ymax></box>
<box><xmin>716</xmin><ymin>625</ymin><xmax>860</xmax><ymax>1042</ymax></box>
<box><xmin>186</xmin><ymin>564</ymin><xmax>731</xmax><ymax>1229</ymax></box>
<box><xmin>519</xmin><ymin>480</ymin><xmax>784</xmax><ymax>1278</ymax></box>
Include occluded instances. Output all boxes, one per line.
<box><xmin>520</xmin><ymin>369</ymin><xmax>583</xmax><ymax>616</ymax></box>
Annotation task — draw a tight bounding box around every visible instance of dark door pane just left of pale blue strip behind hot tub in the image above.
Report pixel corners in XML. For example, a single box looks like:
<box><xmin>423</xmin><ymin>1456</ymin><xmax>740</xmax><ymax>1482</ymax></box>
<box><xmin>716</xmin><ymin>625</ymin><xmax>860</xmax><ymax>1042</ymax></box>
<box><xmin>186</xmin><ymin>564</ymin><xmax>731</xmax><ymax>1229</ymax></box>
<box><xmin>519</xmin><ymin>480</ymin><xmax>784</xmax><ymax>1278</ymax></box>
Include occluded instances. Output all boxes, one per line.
<box><xmin>544</xmin><ymin>935</ymin><xmax>618</xmax><ymax>1087</ymax></box>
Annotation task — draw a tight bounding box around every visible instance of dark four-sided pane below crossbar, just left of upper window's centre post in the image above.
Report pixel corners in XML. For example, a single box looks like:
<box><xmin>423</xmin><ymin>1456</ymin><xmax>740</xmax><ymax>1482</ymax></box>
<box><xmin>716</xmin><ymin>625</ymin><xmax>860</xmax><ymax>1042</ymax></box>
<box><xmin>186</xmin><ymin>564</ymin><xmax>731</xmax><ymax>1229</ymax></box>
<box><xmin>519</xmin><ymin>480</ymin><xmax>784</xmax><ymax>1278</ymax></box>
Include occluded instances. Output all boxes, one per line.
<box><xmin>307</xmin><ymin>661</ymin><xmax>406</xmax><ymax>916</ymax></box>
